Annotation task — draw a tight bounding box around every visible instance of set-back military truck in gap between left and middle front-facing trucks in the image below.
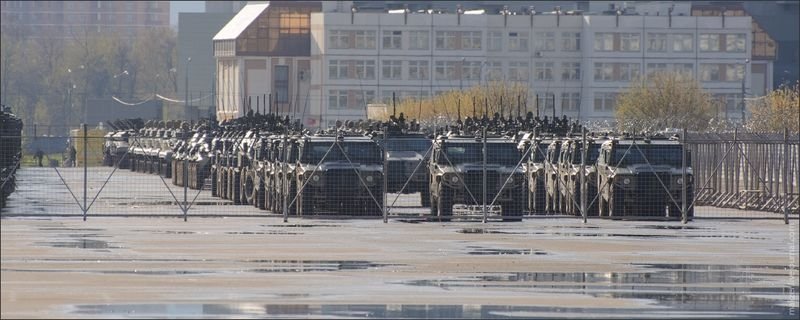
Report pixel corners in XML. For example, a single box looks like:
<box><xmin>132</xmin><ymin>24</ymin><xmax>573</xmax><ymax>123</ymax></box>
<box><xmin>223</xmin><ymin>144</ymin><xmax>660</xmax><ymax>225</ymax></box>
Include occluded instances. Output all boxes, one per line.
<box><xmin>375</xmin><ymin>129</ymin><xmax>431</xmax><ymax>207</ymax></box>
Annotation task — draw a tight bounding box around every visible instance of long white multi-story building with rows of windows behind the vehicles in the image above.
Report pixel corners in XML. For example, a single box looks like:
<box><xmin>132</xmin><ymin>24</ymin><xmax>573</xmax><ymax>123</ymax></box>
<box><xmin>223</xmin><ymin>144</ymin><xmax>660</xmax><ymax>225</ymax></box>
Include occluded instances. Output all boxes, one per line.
<box><xmin>214</xmin><ymin>1</ymin><xmax>752</xmax><ymax>126</ymax></box>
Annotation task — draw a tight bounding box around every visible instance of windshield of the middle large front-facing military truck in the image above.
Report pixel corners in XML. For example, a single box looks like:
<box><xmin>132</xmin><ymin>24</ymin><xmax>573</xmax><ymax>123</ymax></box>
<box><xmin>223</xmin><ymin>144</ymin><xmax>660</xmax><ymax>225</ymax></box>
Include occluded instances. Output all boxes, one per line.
<box><xmin>439</xmin><ymin>142</ymin><xmax>522</xmax><ymax>166</ymax></box>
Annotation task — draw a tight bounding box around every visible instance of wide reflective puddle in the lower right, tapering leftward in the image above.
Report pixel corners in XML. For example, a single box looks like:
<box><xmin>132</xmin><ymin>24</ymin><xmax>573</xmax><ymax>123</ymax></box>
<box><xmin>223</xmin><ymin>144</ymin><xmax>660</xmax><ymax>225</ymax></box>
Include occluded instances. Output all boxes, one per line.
<box><xmin>401</xmin><ymin>264</ymin><xmax>798</xmax><ymax>318</ymax></box>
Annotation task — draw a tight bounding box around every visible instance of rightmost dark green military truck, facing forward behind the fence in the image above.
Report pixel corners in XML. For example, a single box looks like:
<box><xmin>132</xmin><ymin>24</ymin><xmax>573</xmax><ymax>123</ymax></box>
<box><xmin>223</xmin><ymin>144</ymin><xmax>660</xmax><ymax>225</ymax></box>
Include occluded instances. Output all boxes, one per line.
<box><xmin>597</xmin><ymin>137</ymin><xmax>694</xmax><ymax>219</ymax></box>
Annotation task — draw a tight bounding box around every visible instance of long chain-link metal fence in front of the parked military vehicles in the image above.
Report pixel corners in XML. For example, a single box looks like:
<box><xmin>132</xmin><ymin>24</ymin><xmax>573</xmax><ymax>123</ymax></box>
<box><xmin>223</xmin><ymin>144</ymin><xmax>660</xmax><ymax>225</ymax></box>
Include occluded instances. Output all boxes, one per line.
<box><xmin>2</xmin><ymin>124</ymin><xmax>800</xmax><ymax>221</ymax></box>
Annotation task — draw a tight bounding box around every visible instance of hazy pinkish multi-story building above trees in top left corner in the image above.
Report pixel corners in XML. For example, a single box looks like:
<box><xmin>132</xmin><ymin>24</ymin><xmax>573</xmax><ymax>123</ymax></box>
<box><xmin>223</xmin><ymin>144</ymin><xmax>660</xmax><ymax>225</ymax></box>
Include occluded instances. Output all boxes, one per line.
<box><xmin>0</xmin><ymin>1</ymin><xmax>169</xmax><ymax>39</ymax></box>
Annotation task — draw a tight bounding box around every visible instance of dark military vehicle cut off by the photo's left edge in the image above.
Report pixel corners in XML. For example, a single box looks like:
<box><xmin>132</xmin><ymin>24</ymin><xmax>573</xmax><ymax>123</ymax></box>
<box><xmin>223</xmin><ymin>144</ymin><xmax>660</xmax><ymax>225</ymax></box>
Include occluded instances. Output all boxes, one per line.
<box><xmin>0</xmin><ymin>105</ymin><xmax>22</xmax><ymax>208</ymax></box>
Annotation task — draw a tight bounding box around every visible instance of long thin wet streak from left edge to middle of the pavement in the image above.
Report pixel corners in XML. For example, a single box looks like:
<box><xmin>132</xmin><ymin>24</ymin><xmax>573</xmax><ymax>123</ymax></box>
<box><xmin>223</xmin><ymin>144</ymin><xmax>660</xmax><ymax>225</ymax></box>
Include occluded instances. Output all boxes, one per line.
<box><xmin>0</xmin><ymin>259</ymin><xmax>402</xmax><ymax>276</ymax></box>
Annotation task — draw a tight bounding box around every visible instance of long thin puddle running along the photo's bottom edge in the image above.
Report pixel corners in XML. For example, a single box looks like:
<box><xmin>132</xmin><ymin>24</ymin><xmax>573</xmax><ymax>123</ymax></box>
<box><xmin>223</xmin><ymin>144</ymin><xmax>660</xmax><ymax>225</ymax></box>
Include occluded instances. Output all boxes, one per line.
<box><xmin>70</xmin><ymin>303</ymin><xmax>790</xmax><ymax>319</ymax></box>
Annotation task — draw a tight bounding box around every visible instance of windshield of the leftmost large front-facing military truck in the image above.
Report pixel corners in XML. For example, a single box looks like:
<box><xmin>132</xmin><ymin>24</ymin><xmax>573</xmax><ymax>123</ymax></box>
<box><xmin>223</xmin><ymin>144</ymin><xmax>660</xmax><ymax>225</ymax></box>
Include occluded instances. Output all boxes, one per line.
<box><xmin>300</xmin><ymin>141</ymin><xmax>383</xmax><ymax>164</ymax></box>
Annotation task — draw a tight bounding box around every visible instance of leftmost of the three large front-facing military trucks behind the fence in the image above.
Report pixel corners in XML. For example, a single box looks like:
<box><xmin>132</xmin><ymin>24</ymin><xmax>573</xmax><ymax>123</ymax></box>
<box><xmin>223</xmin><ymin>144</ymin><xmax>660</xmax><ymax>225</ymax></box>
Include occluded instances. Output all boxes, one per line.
<box><xmin>290</xmin><ymin>131</ymin><xmax>384</xmax><ymax>216</ymax></box>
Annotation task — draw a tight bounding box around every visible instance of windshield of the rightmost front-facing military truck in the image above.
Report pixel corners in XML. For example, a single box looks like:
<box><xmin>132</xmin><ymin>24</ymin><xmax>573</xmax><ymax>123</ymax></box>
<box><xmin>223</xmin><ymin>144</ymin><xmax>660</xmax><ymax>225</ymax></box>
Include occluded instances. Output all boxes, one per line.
<box><xmin>611</xmin><ymin>143</ymin><xmax>688</xmax><ymax>168</ymax></box>
